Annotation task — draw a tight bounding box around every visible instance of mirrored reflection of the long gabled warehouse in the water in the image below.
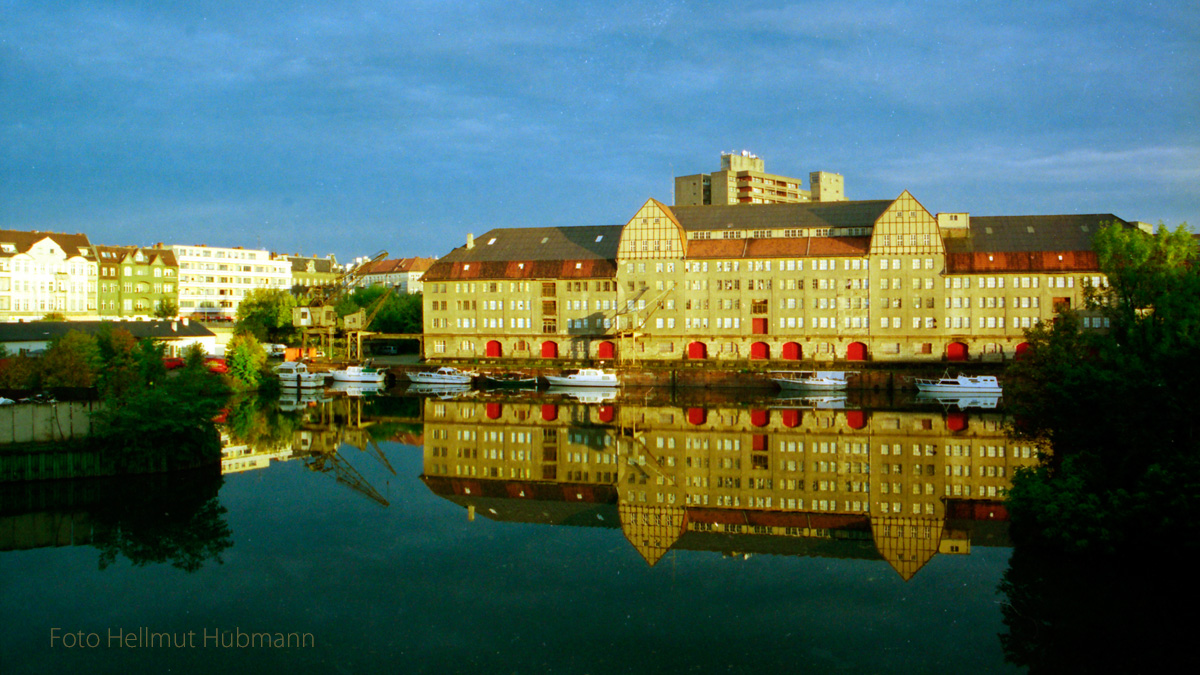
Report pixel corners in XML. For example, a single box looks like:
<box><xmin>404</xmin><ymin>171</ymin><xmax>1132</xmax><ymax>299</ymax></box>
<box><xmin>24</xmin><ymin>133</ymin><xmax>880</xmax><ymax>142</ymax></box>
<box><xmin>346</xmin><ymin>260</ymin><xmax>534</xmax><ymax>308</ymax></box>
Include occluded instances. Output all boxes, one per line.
<box><xmin>422</xmin><ymin>399</ymin><xmax>1037</xmax><ymax>580</ymax></box>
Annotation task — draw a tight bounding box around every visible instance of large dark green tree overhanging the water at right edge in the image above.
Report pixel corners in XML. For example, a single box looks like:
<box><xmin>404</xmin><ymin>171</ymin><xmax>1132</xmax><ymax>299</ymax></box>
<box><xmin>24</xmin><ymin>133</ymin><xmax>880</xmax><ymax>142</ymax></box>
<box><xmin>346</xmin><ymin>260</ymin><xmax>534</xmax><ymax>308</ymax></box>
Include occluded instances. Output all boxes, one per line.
<box><xmin>1006</xmin><ymin>220</ymin><xmax>1200</xmax><ymax>552</ymax></box>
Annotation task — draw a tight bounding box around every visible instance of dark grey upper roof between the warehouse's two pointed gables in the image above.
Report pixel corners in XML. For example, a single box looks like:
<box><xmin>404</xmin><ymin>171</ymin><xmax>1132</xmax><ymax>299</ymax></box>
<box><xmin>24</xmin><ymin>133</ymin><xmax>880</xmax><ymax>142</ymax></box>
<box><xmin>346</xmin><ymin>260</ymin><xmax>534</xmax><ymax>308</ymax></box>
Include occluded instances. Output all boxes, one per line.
<box><xmin>667</xmin><ymin>199</ymin><xmax>895</xmax><ymax>232</ymax></box>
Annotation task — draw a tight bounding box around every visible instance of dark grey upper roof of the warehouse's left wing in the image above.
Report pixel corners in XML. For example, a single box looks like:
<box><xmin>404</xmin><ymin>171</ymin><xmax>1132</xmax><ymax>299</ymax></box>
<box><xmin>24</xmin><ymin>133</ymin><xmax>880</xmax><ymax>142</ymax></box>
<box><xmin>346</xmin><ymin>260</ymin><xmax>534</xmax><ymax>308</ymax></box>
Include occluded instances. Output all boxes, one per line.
<box><xmin>438</xmin><ymin>225</ymin><xmax>624</xmax><ymax>263</ymax></box>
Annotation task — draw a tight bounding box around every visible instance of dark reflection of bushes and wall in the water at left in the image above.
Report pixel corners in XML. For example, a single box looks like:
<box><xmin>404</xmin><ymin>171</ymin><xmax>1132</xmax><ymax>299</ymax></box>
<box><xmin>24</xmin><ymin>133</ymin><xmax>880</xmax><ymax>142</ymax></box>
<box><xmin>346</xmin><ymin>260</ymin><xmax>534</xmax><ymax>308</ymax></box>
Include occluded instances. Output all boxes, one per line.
<box><xmin>0</xmin><ymin>471</ymin><xmax>233</xmax><ymax>572</ymax></box>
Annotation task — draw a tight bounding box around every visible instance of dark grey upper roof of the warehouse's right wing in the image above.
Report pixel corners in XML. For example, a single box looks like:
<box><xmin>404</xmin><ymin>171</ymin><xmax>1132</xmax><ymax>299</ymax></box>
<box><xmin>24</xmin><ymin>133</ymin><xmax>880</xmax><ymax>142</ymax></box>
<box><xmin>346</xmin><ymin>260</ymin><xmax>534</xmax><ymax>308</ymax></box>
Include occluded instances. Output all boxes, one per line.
<box><xmin>946</xmin><ymin>214</ymin><xmax>1134</xmax><ymax>253</ymax></box>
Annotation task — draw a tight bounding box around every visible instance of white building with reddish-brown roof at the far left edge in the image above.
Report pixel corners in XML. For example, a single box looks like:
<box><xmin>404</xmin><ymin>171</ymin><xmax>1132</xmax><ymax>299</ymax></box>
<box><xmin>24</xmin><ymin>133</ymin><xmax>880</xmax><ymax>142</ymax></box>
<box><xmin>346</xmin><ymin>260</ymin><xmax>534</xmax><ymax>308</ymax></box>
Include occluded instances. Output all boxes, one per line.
<box><xmin>0</xmin><ymin>229</ymin><xmax>97</xmax><ymax>321</ymax></box>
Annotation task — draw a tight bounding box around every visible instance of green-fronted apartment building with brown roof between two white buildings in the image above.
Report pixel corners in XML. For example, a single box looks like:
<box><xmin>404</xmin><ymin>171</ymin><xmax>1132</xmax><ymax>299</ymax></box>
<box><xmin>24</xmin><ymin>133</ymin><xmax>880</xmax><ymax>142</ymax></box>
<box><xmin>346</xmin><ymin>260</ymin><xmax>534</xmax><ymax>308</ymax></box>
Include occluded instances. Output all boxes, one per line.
<box><xmin>95</xmin><ymin>246</ymin><xmax>179</xmax><ymax>318</ymax></box>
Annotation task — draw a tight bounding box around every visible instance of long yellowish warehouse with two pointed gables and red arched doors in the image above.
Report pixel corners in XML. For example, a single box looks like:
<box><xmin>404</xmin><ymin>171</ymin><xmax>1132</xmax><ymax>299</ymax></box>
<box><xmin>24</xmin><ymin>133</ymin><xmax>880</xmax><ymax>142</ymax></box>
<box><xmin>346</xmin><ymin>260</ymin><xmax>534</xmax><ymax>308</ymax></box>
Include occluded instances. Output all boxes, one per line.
<box><xmin>424</xmin><ymin>191</ymin><xmax>1133</xmax><ymax>362</ymax></box>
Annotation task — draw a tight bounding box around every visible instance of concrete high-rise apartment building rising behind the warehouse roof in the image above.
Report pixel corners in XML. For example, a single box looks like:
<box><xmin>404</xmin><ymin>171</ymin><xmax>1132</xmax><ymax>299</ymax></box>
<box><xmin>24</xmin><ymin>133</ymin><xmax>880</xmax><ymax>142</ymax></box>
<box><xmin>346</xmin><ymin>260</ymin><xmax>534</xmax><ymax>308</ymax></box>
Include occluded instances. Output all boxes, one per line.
<box><xmin>674</xmin><ymin>150</ymin><xmax>846</xmax><ymax>207</ymax></box>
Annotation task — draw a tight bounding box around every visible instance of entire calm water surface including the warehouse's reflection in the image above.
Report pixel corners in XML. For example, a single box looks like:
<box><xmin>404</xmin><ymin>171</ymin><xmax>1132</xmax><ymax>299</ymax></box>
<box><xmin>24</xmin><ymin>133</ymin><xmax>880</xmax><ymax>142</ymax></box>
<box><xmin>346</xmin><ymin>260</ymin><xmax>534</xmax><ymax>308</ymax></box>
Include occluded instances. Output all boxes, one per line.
<box><xmin>0</xmin><ymin>389</ymin><xmax>1027</xmax><ymax>674</ymax></box>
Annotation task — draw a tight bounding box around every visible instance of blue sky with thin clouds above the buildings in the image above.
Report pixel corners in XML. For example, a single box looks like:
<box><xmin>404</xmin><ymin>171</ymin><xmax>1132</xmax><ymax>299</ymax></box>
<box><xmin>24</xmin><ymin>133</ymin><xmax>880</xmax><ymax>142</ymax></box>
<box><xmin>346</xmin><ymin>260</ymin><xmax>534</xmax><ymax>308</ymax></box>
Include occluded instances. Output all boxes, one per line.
<box><xmin>0</xmin><ymin>0</ymin><xmax>1200</xmax><ymax>262</ymax></box>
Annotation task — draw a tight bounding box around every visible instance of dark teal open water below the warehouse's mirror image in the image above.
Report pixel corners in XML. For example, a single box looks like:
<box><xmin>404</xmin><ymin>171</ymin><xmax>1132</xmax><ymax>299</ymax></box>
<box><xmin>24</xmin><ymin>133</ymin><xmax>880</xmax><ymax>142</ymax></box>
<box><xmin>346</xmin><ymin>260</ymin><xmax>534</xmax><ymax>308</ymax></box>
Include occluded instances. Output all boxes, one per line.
<box><xmin>0</xmin><ymin>391</ymin><xmax>1015</xmax><ymax>674</ymax></box>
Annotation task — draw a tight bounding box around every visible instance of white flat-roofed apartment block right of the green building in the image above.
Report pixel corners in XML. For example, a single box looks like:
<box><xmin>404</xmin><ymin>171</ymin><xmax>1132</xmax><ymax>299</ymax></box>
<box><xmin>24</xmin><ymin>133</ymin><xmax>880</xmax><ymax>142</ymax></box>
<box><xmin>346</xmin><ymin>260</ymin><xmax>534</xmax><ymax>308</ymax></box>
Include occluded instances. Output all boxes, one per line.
<box><xmin>170</xmin><ymin>245</ymin><xmax>292</xmax><ymax>319</ymax></box>
